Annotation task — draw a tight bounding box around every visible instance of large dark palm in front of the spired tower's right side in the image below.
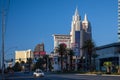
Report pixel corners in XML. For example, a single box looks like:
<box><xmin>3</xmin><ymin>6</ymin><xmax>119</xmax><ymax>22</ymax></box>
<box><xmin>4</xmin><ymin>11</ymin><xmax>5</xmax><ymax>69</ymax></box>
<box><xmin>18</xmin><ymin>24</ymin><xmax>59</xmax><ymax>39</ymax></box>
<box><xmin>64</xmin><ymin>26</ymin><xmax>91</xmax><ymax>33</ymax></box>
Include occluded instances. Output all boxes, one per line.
<box><xmin>82</xmin><ymin>40</ymin><xmax>95</xmax><ymax>69</ymax></box>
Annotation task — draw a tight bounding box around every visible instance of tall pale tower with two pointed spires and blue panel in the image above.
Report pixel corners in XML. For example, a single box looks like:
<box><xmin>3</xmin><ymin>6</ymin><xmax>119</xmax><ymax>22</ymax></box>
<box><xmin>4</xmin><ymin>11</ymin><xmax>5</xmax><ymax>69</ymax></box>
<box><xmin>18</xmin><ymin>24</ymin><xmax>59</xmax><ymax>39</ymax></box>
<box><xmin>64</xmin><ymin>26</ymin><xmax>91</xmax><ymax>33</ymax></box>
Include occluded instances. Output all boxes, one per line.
<box><xmin>70</xmin><ymin>8</ymin><xmax>92</xmax><ymax>57</ymax></box>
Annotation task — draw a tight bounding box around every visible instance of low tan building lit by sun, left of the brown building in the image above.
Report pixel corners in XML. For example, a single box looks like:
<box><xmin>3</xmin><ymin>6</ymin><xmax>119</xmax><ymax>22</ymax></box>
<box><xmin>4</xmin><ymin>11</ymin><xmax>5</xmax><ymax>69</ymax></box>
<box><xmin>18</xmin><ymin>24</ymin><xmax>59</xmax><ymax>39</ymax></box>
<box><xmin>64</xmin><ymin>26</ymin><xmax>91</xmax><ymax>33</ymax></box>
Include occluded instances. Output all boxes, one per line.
<box><xmin>15</xmin><ymin>49</ymin><xmax>33</xmax><ymax>62</ymax></box>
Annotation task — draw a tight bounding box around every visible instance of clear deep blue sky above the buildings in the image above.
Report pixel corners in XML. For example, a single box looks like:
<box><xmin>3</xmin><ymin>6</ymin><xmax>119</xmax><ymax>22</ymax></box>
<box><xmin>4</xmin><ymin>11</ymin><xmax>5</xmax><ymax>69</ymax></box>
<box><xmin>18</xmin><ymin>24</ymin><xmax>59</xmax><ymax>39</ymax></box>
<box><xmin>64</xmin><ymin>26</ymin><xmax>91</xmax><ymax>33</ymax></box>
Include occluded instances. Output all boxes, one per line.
<box><xmin>0</xmin><ymin>0</ymin><xmax>118</xmax><ymax>59</ymax></box>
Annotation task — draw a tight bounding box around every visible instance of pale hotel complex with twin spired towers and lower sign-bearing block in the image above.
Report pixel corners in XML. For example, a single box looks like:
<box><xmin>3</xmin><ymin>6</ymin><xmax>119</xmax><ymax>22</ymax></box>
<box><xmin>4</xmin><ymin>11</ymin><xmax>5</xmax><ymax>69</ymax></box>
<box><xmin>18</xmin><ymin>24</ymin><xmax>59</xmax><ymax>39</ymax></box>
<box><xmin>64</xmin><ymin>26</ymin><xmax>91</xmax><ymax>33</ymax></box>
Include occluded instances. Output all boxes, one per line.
<box><xmin>53</xmin><ymin>8</ymin><xmax>92</xmax><ymax>71</ymax></box>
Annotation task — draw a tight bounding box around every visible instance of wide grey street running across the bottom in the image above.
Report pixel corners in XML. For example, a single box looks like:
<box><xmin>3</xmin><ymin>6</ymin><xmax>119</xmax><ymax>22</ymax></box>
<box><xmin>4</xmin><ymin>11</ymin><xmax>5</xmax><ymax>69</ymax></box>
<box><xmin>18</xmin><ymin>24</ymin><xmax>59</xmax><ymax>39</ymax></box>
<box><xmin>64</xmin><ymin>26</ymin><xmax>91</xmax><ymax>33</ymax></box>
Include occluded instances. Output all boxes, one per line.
<box><xmin>1</xmin><ymin>72</ymin><xmax>120</xmax><ymax>80</ymax></box>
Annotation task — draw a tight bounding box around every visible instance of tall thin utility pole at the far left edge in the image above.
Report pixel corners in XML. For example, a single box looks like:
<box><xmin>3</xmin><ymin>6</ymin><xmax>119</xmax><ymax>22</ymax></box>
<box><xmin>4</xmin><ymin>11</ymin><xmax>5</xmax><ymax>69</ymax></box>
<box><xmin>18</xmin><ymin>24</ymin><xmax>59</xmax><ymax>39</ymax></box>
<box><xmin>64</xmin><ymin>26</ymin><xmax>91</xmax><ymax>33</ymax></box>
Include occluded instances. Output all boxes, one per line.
<box><xmin>1</xmin><ymin>2</ymin><xmax>5</xmax><ymax>80</ymax></box>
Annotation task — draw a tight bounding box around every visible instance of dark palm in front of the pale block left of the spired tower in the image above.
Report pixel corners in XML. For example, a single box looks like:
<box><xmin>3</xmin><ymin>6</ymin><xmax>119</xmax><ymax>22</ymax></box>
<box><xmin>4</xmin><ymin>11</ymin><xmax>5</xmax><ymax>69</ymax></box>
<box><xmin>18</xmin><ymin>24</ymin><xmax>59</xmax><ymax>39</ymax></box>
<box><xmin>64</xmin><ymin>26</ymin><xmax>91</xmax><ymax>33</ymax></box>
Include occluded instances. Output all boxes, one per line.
<box><xmin>58</xmin><ymin>43</ymin><xmax>66</xmax><ymax>71</ymax></box>
